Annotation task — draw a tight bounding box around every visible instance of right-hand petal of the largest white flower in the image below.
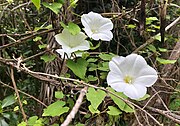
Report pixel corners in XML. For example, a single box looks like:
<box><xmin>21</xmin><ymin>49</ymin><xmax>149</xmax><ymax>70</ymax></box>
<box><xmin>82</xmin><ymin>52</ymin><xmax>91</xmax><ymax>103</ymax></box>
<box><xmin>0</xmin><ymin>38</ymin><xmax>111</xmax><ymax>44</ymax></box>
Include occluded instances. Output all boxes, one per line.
<box><xmin>134</xmin><ymin>66</ymin><xmax>158</xmax><ymax>87</ymax></box>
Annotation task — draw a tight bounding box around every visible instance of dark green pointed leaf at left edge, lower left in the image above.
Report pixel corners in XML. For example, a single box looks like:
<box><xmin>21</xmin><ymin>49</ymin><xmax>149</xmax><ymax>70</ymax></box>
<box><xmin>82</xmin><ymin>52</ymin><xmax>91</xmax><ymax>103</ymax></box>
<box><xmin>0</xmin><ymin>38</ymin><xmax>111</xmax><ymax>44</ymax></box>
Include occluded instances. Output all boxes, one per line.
<box><xmin>2</xmin><ymin>95</ymin><xmax>16</xmax><ymax>108</ymax></box>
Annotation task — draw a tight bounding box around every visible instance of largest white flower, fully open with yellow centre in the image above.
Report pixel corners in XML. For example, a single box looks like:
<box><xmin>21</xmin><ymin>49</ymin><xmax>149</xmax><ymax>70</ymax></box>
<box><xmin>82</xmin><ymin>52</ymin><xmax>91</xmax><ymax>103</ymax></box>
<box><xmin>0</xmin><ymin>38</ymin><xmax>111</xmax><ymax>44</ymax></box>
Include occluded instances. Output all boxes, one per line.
<box><xmin>107</xmin><ymin>54</ymin><xmax>158</xmax><ymax>99</ymax></box>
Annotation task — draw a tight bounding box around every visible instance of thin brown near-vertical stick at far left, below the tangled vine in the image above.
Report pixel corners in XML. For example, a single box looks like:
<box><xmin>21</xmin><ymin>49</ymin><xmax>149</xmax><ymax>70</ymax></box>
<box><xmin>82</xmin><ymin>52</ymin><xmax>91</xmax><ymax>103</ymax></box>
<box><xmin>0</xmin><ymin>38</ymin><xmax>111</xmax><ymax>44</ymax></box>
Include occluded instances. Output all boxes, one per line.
<box><xmin>11</xmin><ymin>67</ymin><xmax>27</xmax><ymax>122</ymax></box>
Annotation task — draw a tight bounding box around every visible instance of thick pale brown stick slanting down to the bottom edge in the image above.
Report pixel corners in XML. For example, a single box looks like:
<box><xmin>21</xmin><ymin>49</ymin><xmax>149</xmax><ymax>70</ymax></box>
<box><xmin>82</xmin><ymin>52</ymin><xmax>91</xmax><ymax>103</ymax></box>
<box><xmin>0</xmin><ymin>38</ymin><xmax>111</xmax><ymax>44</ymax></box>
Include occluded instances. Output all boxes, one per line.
<box><xmin>61</xmin><ymin>87</ymin><xmax>88</xmax><ymax>126</ymax></box>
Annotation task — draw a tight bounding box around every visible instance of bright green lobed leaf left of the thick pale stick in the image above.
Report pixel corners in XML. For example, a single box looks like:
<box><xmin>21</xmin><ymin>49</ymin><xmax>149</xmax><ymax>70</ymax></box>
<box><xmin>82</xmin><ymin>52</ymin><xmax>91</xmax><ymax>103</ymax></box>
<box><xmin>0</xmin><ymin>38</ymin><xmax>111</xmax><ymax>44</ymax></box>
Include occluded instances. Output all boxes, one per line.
<box><xmin>42</xmin><ymin>101</ymin><xmax>69</xmax><ymax>117</ymax></box>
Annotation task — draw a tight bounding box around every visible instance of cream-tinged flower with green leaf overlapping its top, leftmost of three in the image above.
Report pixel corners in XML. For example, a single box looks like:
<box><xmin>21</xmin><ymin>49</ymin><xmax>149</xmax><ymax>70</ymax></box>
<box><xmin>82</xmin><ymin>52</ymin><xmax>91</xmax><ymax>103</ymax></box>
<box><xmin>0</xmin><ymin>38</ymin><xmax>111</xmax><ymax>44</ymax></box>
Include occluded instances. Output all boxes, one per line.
<box><xmin>55</xmin><ymin>29</ymin><xmax>90</xmax><ymax>58</ymax></box>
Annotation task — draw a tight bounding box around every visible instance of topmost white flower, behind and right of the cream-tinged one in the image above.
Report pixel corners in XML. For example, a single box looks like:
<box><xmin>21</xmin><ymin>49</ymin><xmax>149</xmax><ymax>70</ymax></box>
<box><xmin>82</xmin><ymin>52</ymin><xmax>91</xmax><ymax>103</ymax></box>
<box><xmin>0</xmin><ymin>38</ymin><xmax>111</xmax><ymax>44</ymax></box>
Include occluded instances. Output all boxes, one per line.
<box><xmin>81</xmin><ymin>12</ymin><xmax>113</xmax><ymax>41</ymax></box>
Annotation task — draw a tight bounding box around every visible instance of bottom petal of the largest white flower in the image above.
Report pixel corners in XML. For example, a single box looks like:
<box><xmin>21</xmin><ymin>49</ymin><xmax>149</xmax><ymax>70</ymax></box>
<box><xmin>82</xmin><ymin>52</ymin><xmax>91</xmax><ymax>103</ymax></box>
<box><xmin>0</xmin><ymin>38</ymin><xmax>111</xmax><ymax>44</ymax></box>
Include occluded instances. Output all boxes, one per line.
<box><xmin>123</xmin><ymin>84</ymin><xmax>147</xmax><ymax>99</ymax></box>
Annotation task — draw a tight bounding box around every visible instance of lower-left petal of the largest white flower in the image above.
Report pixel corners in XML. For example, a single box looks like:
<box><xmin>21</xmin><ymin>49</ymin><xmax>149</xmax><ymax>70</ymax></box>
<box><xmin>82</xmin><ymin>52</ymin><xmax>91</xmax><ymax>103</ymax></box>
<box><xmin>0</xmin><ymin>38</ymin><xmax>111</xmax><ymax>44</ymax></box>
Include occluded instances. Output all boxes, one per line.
<box><xmin>107</xmin><ymin>72</ymin><xmax>127</xmax><ymax>92</ymax></box>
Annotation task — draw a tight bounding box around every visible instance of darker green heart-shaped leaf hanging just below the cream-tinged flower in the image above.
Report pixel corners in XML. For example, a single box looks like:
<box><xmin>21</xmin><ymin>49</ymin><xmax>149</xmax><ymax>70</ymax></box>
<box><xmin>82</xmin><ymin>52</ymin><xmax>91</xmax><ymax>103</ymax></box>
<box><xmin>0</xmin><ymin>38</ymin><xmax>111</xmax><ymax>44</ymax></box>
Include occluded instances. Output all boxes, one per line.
<box><xmin>67</xmin><ymin>58</ymin><xmax>88</xmax><ymax>79</ymax></box>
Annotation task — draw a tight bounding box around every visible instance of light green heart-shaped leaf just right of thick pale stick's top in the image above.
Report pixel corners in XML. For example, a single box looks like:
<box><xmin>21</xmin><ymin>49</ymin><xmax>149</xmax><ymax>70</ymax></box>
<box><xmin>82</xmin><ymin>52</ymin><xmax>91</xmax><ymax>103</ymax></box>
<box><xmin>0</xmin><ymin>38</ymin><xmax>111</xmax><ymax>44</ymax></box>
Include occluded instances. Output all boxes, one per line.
<box><xmin>86</xmin><ymin>88</ymin><xmax>106</xmax><ymax>110</ymax></box>
